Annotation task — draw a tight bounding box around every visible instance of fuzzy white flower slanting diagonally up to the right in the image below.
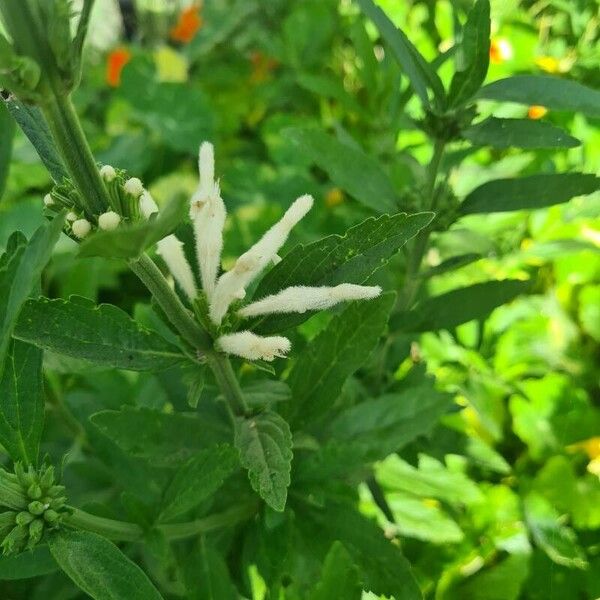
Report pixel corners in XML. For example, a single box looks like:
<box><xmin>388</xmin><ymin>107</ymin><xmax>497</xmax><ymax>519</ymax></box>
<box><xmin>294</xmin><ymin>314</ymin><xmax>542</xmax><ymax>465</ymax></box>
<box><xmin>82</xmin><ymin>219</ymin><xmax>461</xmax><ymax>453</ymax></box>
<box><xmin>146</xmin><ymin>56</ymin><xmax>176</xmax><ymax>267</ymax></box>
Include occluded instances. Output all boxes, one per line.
<box><xmin>210</xmin><ymin>195</ymin><xmax>313</xmax><ymax>325</ymax></box>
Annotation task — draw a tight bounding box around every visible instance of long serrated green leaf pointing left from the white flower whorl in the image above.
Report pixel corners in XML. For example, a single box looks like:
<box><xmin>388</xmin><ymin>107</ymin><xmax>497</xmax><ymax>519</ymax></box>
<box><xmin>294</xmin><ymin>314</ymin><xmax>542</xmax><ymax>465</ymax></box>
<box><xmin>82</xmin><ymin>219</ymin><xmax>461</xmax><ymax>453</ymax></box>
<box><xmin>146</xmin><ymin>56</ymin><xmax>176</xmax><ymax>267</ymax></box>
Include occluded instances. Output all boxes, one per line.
<box><xmin>14</xmin><ymin>296</ymin><xmax>185</xmax><ymax>371</ymax></box>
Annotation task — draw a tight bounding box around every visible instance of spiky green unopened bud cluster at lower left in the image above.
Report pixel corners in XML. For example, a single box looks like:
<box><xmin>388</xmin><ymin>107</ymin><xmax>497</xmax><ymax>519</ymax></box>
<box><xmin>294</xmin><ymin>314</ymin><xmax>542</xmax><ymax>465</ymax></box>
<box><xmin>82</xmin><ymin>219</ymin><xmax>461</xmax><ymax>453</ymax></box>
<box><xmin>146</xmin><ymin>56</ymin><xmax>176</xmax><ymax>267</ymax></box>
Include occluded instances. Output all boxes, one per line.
<box><xmin>0</xmin><ymin>463</ymin><xmax>68</xmax><ymax>555</ymax></box>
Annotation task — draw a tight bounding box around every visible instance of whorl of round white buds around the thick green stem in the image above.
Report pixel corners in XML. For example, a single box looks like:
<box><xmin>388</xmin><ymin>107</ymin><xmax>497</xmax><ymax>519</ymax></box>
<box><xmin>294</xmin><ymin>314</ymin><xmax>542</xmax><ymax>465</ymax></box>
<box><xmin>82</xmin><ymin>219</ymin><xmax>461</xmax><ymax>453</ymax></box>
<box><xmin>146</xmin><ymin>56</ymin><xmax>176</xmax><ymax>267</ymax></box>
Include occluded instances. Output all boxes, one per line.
<box><xmin>44</xmin><ymin>165</ymin><xmax>158</xmax><ymax>241</ymax></box>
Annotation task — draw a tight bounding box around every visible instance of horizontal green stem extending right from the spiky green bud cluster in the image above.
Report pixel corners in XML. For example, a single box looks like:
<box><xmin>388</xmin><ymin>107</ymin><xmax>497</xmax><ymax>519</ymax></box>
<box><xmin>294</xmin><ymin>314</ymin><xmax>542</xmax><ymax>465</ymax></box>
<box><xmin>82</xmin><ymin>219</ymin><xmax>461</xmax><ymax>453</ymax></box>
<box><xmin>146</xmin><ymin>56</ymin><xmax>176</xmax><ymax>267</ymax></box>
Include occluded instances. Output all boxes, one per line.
<box><xmin>65</xmin><ymin>503</ymin><xmax>257</xmax><ymax>542</ymax></box>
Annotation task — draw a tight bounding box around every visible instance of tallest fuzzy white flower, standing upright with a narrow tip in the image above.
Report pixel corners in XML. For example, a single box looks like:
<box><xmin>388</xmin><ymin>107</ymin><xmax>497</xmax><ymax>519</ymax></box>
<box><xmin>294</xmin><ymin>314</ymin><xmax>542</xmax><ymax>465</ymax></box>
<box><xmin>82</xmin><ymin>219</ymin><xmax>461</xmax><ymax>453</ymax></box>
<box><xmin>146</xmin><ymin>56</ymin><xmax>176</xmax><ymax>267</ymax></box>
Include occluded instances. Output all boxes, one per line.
<box><xmin>190</xmin><ymin>142</ymin><xmax>227</xmax><ymax>300</ymax></box>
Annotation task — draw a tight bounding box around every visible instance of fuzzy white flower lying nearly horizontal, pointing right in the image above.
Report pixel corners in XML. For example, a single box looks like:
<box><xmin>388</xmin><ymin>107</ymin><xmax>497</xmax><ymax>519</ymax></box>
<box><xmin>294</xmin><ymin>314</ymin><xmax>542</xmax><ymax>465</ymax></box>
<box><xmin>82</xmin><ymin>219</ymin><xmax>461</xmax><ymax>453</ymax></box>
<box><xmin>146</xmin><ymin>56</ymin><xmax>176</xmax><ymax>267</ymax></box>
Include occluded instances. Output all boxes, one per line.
<box><xmin>238</xmin><ymin>283</ymin><xmax>381</xmax><ymax>317</ymax></box>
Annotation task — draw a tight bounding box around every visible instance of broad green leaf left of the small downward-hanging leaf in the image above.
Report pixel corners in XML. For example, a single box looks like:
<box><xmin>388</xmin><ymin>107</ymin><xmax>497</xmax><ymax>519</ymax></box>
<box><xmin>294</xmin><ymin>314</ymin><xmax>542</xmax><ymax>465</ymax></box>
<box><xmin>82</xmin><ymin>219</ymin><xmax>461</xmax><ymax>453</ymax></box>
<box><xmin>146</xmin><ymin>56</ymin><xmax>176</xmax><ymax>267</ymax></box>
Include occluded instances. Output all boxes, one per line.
<box><xmin>90</xmin><ymin>408</ymin><xmax>231</xmax><ymax>467</ymax></box>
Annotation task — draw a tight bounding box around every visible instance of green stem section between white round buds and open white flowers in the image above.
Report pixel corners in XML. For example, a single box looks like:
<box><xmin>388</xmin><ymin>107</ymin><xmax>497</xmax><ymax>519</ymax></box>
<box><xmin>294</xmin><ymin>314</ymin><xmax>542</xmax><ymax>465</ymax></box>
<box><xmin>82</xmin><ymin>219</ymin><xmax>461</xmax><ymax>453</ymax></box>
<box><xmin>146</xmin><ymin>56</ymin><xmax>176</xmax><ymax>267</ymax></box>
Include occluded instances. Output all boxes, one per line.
<box><xmin>129</xmin><ymin>254</ymin><xmax>212</xmax><ymax>353</ymax></box>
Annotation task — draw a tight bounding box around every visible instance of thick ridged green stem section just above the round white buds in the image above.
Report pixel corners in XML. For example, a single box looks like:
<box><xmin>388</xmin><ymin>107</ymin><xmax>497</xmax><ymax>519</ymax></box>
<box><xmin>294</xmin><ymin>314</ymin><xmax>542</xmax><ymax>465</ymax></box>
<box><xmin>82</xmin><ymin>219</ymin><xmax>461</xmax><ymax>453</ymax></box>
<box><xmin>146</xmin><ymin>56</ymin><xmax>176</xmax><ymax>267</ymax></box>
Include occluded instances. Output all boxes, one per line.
<box><xmin>41</xmin><ymin>94</ymin><xmax>110</xmax><ymax>217</ymax></box>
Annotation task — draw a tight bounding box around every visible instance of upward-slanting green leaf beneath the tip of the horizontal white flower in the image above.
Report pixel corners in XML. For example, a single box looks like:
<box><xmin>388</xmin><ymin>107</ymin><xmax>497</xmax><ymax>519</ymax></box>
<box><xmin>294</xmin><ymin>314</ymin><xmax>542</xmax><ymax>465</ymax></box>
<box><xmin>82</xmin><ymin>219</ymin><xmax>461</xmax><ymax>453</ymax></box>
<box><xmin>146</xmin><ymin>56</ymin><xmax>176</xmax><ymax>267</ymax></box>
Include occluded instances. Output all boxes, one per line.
<box><xmin>288</xmin><ymin>292</ymin><xmax>396</xmax><ymax>424</ymax></box>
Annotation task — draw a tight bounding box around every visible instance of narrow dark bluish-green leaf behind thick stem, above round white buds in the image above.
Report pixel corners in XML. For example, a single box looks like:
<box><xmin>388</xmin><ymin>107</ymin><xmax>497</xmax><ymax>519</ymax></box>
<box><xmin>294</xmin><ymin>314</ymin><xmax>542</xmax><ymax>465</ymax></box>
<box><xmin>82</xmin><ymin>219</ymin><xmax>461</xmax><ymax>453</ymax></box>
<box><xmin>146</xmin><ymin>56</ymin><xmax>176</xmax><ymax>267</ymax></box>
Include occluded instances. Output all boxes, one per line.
<box><xmin>4</xmin><ymin>95</ymin><xmax>68</xmax><ymax>183</ymax></box>
